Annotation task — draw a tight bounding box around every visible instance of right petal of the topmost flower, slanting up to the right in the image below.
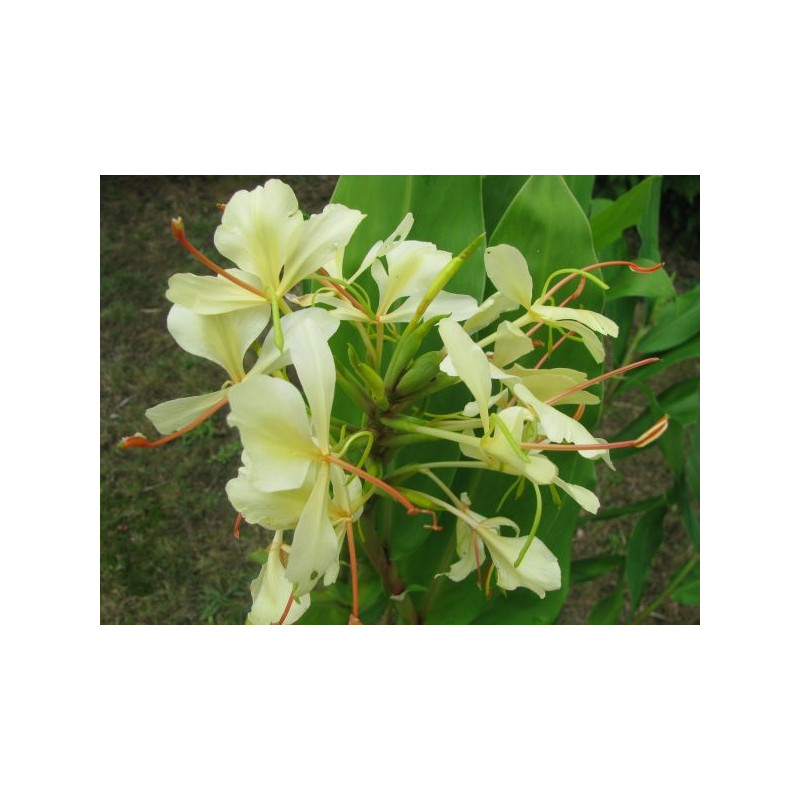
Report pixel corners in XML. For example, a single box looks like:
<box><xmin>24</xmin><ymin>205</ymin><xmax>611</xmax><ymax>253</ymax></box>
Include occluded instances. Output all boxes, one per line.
<box><xmin>280</xmin><ymin>203</ymin><xmax>365</xmax><ymax>294</ymax></box>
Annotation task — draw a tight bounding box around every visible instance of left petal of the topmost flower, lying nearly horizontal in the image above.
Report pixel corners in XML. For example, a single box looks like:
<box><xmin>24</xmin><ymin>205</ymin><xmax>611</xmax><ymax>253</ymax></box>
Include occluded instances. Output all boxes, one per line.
<box><xmin>166</xmin><ymin>269</ymin><xmax>269</xmax><ymax>316</ymax></box>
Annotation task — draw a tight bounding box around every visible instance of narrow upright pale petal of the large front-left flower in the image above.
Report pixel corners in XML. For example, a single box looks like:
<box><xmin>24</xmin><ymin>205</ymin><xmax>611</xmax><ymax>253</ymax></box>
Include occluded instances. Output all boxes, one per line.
<box><xmin>284</xmin><ymin>312</ymin><xmax>336</xmax><ymax>453</ymax></box>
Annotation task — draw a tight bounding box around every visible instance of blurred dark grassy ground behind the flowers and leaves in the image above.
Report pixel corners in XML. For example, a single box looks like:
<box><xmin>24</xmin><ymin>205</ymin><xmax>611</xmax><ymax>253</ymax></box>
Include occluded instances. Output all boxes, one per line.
<box><xmin>100</xmin><ymin>175</ymin><xmax>699</xmax><ymax>624</ymax></box>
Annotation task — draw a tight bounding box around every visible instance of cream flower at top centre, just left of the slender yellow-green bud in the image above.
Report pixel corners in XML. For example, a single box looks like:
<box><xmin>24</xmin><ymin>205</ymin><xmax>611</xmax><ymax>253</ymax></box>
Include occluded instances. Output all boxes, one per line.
<box><xmin>310</xmin><ymin>214</ymin><xmax>478</xmax><ymax>324</ymax></box>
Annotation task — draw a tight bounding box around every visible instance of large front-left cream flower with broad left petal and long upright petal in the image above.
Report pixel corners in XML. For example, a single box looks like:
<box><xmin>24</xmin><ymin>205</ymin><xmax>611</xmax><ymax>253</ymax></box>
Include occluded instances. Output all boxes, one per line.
<box><xmin>228</xmin><ymin>312</ymin><xmax>348</xmax><ymax>596</ymax></box>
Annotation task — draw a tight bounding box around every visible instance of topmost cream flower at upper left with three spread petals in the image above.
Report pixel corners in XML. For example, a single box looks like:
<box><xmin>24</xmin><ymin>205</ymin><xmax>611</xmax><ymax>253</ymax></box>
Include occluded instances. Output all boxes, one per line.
<box><xmin>167</xmin><ymin>179</ymin><xmax>365</xmax><ymax>314</ymax></box>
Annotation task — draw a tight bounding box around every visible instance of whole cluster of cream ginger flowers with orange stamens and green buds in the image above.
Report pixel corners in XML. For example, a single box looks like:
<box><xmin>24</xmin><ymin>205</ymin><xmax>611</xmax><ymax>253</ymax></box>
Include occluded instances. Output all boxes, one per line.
<box><xmin>121</xmin><ymin>180</ymin><xmax>667</xmax><ymax>624</ymax></box>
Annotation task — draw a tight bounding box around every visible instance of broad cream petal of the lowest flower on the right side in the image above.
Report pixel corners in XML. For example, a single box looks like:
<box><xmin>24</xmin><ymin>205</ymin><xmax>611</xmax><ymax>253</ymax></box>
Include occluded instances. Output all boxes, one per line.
<box><xmin>479</xmin><ymin>527</ymin><xmax>561</xmax><ymax>597</ymax></box>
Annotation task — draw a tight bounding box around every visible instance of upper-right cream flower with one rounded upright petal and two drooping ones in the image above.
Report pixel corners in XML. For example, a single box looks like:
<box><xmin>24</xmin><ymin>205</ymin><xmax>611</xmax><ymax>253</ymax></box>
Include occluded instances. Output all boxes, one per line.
<box><xmin>485</xmin><ymin>244</ymin><xmax>619</xmax><ymax>363</ymax></box>
